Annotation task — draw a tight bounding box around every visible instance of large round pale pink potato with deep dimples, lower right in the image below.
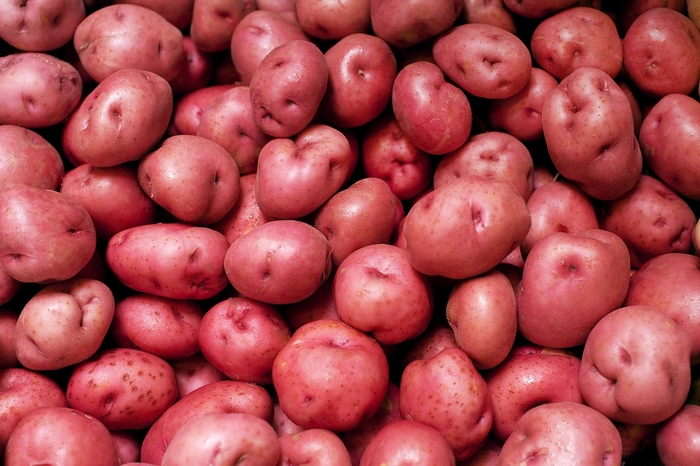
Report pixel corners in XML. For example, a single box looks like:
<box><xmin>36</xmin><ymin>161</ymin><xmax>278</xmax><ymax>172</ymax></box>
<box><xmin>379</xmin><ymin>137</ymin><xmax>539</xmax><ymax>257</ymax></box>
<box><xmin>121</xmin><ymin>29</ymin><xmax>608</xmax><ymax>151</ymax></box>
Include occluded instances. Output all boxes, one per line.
<box><xmin>579</xmin><ymin>305</ymin><xmax>693</xmax><ymax>424</ymax></box>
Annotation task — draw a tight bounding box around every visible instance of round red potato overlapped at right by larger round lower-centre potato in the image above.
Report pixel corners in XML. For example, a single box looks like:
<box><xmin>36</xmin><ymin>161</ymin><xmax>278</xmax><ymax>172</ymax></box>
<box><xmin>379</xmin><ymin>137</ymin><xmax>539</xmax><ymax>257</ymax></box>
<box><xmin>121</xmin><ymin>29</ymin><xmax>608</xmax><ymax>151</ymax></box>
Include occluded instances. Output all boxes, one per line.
<box><xmin>199</xmin><ymin>297</ymin><xmax>291</xmax><ymax>385</ymax></box>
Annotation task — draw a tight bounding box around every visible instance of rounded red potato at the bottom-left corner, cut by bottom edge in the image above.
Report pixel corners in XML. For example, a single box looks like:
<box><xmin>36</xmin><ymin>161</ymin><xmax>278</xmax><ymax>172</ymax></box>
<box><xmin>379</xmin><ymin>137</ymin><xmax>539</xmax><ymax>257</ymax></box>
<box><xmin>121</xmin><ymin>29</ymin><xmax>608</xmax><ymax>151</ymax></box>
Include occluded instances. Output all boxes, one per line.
<box><xmin>5</xmin><ymin>407</ymin><xmax>119</xmax><ymax>466</ymax></box>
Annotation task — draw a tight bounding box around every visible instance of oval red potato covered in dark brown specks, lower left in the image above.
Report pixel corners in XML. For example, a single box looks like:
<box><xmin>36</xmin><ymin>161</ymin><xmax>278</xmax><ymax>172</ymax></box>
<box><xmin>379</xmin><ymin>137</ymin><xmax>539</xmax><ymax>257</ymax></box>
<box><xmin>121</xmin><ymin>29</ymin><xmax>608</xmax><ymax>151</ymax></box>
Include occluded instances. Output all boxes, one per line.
<box><xmin>66</xmin><ymin>348</ymin><xmax>177</xmax><ymax>430</ymax></box>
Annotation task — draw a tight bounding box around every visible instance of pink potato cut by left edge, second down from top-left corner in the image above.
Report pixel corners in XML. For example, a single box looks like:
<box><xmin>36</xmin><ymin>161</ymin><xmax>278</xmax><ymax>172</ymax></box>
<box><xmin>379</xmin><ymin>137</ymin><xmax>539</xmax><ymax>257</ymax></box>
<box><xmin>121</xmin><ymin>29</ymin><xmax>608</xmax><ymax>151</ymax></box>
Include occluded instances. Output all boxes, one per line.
<box><xmin>0</xmin><ymin>52</ymin><xmax>83</xmax><ymax>128</ymax></box>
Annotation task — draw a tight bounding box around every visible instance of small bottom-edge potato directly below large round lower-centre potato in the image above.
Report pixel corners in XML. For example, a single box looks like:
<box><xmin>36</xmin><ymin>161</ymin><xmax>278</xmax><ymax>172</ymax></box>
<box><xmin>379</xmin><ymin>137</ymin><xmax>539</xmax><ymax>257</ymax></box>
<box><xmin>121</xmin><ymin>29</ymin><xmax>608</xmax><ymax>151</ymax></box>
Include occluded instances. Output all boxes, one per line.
<box><xmin>279</xmin><ymin>429</ymin><xmax>352</xmax><ymax>466</ymax></box>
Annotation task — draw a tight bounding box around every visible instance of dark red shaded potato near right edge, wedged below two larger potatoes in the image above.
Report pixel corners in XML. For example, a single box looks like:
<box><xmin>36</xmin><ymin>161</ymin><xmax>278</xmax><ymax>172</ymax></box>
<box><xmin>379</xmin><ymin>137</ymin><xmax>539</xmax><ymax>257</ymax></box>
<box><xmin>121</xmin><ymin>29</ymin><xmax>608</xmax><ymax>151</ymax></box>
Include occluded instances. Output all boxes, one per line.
<box><xmin>600</xmin><ymin>175</ymin><xmax>696</xmax><ymax>269</ymax></box>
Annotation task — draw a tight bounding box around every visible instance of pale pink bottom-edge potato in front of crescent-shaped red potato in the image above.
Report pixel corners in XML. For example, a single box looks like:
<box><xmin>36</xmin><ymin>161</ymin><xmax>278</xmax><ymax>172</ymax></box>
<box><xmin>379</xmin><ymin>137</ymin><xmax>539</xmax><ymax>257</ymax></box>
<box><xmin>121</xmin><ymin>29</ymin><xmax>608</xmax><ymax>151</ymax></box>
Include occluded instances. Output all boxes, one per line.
<box><xmin>160</xmin><ymin>413</ymin><xmax>281</xmax><ymax>466</ymax></box>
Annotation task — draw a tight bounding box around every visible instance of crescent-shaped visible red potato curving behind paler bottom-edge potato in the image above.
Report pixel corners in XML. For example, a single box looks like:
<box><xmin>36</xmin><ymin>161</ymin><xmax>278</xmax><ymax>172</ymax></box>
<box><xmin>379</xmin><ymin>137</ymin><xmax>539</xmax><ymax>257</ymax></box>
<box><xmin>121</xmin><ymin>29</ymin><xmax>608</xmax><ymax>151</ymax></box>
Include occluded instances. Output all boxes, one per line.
<box><xmin>141</xmin><ymin>380</ymin><xmax>273</xmax><ymax>464</ymax></box>
